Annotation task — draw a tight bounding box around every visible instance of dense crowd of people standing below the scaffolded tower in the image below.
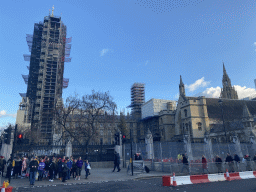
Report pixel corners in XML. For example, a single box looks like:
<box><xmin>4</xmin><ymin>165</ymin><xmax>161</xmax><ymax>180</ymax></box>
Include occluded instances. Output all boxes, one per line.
<box><xmin>0</xmin><ymin>155</ymin><xmax>91</xmax><ymax>185</ymax></box>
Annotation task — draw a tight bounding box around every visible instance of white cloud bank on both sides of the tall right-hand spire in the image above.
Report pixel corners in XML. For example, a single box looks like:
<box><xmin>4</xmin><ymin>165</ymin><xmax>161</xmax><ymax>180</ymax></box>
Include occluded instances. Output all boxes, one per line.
<box><xmin>195</xmin><ymin>85</ymin><xmax>256</xmax><ymax>99</ymax></box>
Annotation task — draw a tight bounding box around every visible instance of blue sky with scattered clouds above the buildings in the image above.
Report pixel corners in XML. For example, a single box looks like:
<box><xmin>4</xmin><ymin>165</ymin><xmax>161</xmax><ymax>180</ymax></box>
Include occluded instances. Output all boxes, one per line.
<box><xmin>0</xmin><ymin>0</ymin><xmax>256</xmax><ymax>127</ymax></box>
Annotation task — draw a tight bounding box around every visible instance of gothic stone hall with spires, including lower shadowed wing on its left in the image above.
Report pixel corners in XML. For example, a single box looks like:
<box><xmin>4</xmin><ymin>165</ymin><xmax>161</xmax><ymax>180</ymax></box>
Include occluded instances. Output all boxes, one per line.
<box><xmin>137</xmin><ymin>64</ymin><xmax>256</xmax><ymax>142</ymax></box>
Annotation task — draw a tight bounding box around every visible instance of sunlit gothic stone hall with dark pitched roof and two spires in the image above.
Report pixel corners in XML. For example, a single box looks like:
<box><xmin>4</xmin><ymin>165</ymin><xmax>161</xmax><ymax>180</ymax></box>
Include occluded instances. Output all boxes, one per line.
<box><xmin>172</xmin><ymin>64</ymin><xmax>256</xmax><ymax>142</ymax></box>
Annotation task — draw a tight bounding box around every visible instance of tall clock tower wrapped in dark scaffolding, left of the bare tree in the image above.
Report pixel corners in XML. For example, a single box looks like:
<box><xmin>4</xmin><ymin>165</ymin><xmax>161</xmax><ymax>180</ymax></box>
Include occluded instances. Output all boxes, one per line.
<box><xmin>20</xmin><ymin>9</ymin><xmax>72</xmax><ymax>144</ymax></box>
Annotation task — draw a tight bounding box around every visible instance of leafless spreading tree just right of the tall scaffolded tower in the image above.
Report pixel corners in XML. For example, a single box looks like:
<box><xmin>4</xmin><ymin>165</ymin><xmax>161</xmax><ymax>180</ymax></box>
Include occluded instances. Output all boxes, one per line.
<box><xmin>55</xmin><ymin>90</ymin><xmax>116</xmax><ymax>152</ymax></box>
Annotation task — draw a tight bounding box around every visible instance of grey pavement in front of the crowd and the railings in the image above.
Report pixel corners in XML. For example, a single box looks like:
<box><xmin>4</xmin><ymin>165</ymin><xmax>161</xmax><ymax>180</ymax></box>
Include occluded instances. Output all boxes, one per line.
<box><xmin>5</xmin><ymin>168</ymin><xmax>166</xmax><ymax>188</ymax></box>
